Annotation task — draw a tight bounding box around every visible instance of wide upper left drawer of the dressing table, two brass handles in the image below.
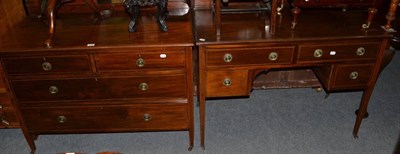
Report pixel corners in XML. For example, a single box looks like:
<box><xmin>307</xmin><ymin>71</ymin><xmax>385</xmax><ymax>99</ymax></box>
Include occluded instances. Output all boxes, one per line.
<box><xmin>206</xmin><ymin>46</ymin><xmax>295</xmax><ymax>67</ymax></box>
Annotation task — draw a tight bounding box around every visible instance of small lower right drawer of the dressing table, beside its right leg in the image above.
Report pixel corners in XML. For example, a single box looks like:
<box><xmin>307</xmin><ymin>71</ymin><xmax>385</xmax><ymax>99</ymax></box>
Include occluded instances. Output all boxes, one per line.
<box><xmin>332</xmin><ymin>64</ymin><xmax>374</xmax><ymax>90</ymax></box>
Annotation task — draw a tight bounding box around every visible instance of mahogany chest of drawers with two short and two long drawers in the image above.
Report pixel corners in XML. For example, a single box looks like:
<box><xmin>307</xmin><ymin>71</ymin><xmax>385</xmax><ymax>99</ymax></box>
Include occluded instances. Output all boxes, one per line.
<box><xmin>0</xmin><ymin>11</ymin><xmax>194</xmax><ymax>152</ymax></box>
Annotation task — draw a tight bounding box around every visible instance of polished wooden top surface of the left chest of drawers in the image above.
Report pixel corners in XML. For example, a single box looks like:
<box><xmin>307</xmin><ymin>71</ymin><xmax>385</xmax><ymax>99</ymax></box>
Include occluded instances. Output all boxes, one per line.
<box><xmin>0</xmin><ymin>6</ymin><xmax>194</xmax><ymax>52</ymax></box>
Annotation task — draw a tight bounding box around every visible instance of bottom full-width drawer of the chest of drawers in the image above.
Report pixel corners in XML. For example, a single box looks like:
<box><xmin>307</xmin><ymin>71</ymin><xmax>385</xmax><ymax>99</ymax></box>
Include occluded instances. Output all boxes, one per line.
<box><xmin>21</xmin><ymin>104</ymin><xmax>190</xmax><ymax>133</ymax></box>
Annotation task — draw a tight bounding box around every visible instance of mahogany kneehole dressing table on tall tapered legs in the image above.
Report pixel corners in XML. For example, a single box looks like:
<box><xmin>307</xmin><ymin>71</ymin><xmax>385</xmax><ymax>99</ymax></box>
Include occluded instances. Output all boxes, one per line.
<box><xmin>194</xmin><ymin>6</ymin><xmax>392</xmax><ymax>149</ymax></box>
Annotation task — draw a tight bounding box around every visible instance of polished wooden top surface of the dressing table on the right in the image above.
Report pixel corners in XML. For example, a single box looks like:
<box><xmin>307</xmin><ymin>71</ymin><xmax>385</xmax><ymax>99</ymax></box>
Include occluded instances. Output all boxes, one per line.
<box><xmin>195</xmin><ymin>9</ymin><xmax>392</xmax><ymax>45</ymax></box>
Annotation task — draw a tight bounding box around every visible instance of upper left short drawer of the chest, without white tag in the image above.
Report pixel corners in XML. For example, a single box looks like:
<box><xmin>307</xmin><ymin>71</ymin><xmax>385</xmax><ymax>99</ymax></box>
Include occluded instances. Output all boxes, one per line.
<box><xmin>3</xmin><ymin>55</ymin><xmax>91</xmax><ymax>74</ymax></box>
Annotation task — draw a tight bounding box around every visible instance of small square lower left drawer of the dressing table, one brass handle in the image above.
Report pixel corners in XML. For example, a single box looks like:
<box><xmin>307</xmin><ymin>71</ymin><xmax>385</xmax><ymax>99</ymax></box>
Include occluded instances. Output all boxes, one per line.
<box><xmin>205</xmin><ymin>70</ymin><xmax>250</xmax><ymax>97</ymax></box>
